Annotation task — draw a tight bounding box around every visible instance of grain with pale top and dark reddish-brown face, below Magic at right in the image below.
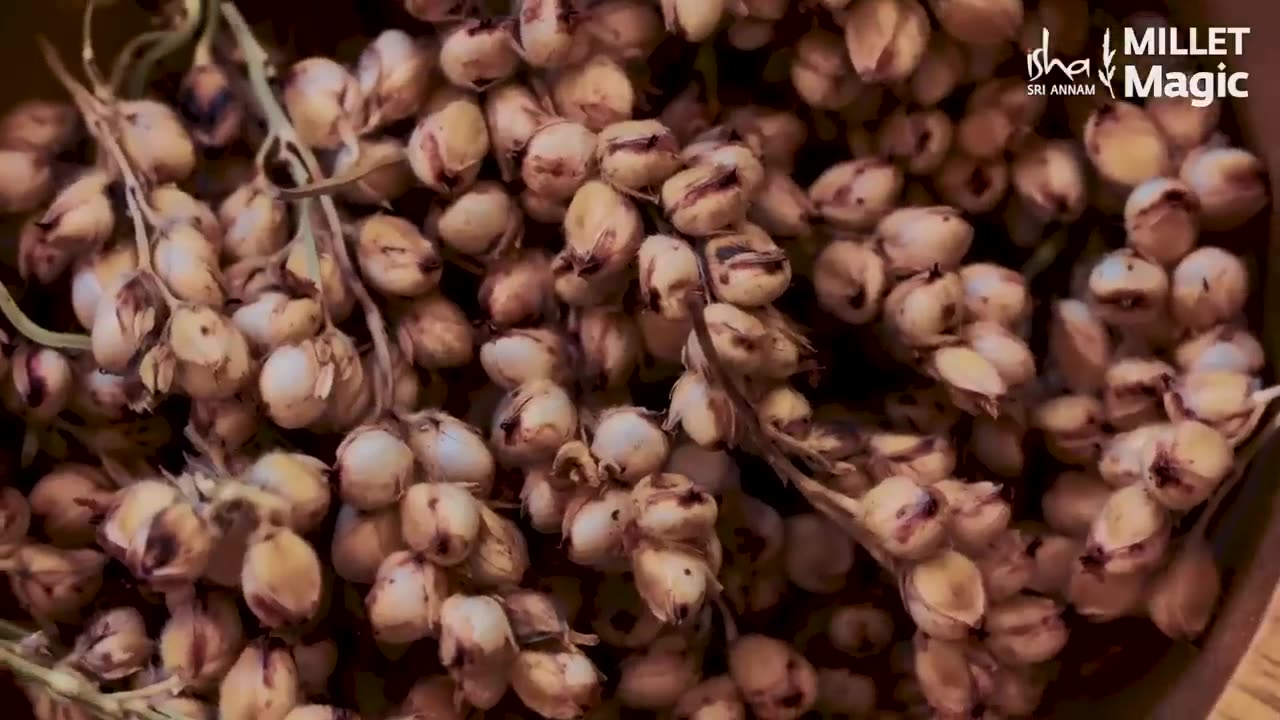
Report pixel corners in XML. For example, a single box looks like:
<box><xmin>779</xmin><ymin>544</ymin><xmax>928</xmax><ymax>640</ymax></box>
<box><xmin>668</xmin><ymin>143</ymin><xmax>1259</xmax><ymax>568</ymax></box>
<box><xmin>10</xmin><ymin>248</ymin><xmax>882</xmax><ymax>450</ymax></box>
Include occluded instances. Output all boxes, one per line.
<box><xmin>1124</xmin><ymin>178</ymin><xmax>1199</xmax><ymax>266</ymax></box>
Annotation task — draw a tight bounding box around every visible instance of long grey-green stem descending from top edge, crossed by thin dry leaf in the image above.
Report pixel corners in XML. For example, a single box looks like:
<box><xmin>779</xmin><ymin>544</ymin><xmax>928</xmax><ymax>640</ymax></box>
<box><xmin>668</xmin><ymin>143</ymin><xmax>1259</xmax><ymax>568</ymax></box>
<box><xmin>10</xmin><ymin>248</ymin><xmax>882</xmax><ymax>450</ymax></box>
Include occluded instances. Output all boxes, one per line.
<box><xmin>223</xmin><ymin>3</ymin><xmax>394</xmax><ymax>415</ymax></box>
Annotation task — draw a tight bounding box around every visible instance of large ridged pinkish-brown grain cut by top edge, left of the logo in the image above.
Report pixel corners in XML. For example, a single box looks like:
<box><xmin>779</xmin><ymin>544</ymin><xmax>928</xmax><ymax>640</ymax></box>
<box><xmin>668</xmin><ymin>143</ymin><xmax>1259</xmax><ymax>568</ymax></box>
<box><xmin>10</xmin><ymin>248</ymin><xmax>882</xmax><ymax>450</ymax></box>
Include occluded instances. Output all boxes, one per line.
<box><xmin>842</xmin><ymin>0</ymin><xmax>931</xmax><ymax>82</ymax></box>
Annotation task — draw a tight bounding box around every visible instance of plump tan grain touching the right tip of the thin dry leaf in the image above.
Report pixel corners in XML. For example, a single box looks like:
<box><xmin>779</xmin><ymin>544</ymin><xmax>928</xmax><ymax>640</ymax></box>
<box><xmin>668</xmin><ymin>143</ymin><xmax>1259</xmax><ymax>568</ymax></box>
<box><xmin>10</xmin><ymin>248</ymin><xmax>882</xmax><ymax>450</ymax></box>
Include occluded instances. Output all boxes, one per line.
<box><xmin>406</xmin><ymin>97</ymin><xmax>489</xmax><ymax>196</ymax></box>
